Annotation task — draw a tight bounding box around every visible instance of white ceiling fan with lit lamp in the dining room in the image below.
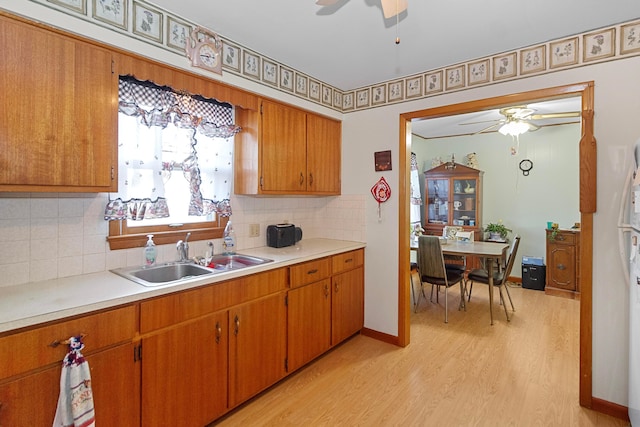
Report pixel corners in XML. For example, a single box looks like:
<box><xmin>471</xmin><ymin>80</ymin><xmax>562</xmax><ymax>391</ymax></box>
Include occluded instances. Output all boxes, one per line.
<box><xmin>460</xmin><ymin>105</ymin><xmax>580</xmax><ymax>136</ymax></box>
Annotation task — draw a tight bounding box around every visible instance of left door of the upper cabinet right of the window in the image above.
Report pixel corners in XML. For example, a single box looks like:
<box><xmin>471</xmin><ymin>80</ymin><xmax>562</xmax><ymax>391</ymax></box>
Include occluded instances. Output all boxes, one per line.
<box><xmin>260</xmin><ymin>101</ymin><xmax>307</xmax><ymax>192</ymax></box>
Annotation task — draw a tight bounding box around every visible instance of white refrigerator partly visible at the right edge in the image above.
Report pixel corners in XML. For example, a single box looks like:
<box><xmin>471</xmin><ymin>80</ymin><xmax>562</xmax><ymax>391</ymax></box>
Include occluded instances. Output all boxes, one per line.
<box><xmin>618</xmin><ymin>140</ymin><xmax>640</xmax><ymax>427</ymax></box>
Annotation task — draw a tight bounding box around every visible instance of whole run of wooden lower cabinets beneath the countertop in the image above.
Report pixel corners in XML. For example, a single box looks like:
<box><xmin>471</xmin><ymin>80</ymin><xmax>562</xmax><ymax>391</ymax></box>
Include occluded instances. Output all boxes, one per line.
<box><xmin>0</xmin><ymin>250</ymin><xmax>364</xmax><ymax>427</ymax></box>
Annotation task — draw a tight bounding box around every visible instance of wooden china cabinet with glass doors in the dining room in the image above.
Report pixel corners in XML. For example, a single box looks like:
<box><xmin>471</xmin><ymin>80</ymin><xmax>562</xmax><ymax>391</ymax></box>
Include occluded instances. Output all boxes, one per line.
<box><xmin>424</xmin><ymin>163</ymin><xmax>483</xmax><ymax>240</ymax></box>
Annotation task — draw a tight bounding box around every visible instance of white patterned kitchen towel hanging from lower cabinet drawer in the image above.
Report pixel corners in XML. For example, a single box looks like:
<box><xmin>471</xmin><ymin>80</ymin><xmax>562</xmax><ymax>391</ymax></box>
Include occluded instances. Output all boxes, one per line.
<box><xmin>53</xmin><ymin>336</ymin><xmax>95</xmax><ymax>427</ymax></box>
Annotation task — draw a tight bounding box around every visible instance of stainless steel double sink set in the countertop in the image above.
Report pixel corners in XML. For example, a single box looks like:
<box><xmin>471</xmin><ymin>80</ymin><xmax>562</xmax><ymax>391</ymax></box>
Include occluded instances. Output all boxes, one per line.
<box><xmin>111</xmin><ymin>254</ymin><xmax>273</xmax><ymax>286</ymax></box>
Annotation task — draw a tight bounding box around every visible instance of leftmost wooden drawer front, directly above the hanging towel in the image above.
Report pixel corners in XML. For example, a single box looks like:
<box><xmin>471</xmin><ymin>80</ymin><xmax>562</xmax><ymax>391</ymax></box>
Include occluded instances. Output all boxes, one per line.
<box><xmin>0</xmin><ymin>305</ymin><xmax>137</xmax><ymax>380</ymax></box>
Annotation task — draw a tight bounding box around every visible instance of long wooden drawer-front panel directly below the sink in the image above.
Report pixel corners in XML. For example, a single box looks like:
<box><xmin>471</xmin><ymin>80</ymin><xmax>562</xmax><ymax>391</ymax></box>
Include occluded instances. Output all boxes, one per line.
<box><xmin>140</xmin><ymin>268</ymin><xmax>287</xmax><ymax>334</ymax></box>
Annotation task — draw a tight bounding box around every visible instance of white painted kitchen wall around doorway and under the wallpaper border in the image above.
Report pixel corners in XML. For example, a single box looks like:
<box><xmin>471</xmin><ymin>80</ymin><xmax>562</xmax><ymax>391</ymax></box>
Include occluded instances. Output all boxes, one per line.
<box><xmin>0</xmin><ymin>1</ymin><xmax>640</xmax><ymax>405</ymax></box>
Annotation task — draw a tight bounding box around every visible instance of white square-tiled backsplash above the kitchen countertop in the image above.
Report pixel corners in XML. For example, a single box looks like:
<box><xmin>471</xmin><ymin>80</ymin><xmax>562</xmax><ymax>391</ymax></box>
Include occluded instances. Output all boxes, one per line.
<box><xmin>0</xmin><ymin>193</ymin><xmax>365</xmax><ymax>287</ymax></box>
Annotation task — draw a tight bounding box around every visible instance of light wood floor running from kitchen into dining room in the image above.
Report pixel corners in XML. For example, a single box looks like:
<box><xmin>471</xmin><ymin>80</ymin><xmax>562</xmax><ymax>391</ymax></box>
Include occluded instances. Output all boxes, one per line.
<box><xmin>216</xmin><ymin>284</ymin><xmax>629</xmax><ymax>427</ymax></box>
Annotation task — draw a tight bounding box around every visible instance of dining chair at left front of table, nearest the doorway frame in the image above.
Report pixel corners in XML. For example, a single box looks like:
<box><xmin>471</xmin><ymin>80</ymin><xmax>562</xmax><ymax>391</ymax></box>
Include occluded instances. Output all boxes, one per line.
<box><xmin>415</xmin><ymin>236</ymin><xmax>465</xmax><ymax>323</ymax></box>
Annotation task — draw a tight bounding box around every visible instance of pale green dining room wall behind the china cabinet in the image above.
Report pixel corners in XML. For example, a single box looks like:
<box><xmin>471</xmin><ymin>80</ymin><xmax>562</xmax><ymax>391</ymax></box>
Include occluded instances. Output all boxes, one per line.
<box><xmin>411</xmin><ymin>124</ymin><xmax>580</xmax><ymax>277</ymax></box>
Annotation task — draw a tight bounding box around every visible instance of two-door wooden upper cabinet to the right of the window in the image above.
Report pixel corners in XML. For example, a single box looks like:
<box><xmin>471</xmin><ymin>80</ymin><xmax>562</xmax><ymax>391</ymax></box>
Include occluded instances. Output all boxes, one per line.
<box><xmin>234</xmin><ymin>100</ymin><xmax>342</xmax><ymax>195</ymax></box>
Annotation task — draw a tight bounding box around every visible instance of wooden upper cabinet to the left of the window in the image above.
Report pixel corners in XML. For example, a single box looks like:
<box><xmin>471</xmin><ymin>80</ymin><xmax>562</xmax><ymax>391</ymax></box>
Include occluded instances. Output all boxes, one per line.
<box><xmin>0</xmin><ymin>15</ymin><xmax>118</xmax><ymax>192</ymax></box>
